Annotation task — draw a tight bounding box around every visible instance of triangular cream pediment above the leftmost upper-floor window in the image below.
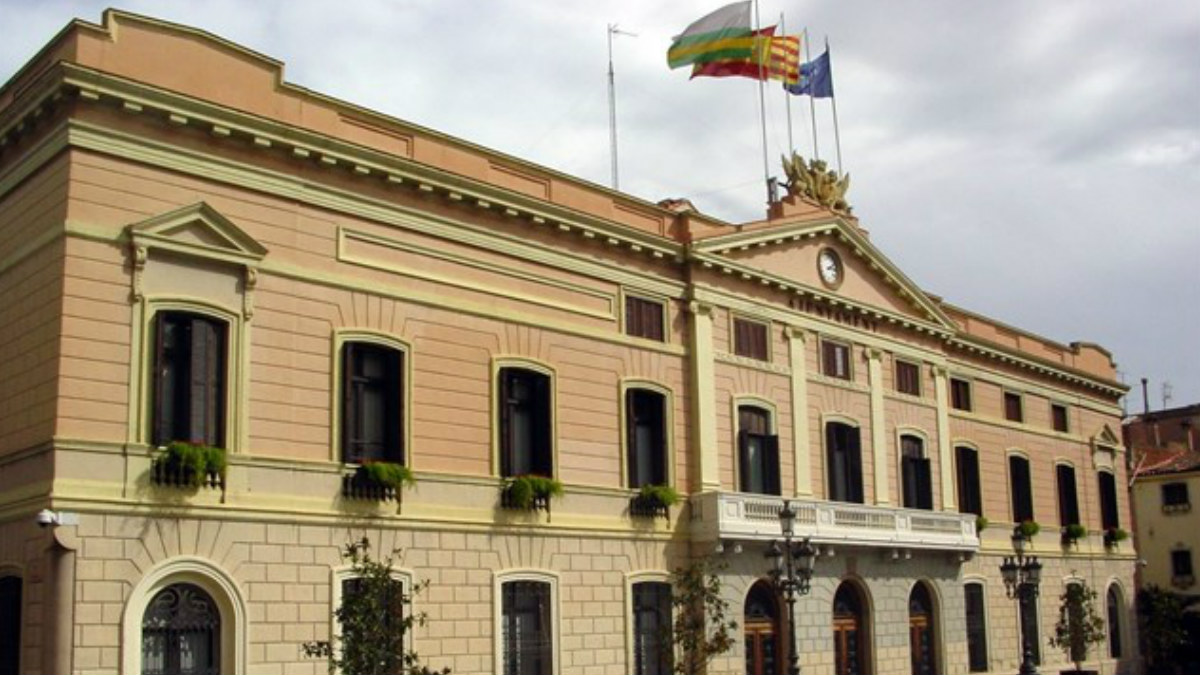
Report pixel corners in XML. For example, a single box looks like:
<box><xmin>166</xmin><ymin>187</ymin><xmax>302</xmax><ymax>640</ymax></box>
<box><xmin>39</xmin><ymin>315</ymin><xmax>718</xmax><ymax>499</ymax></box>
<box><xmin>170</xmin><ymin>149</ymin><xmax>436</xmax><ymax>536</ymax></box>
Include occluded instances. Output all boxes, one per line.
<box><xmin>128</xmin><ymin>202</ymin><xmax>266</xmax><ymax>268</ymax></box>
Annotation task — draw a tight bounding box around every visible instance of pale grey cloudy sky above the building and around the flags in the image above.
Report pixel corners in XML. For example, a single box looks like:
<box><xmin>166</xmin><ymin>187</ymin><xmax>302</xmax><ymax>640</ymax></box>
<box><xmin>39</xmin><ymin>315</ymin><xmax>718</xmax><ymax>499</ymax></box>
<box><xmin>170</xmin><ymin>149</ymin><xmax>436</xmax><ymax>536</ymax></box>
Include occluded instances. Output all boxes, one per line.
<box><xmin>0</xmin><ymin>0</ymin><xmax>1200</xmax><ymax>412</ymax></box>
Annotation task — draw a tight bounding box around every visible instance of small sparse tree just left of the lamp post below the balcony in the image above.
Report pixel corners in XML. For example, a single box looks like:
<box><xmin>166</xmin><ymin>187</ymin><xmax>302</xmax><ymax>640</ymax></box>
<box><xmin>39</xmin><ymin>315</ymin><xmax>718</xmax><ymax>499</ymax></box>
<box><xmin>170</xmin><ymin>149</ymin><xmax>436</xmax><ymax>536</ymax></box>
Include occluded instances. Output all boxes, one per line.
<box><xmin>671</xmin><ymin>558</ymin><xmax>738</xmax><ymax>675</ymax></box>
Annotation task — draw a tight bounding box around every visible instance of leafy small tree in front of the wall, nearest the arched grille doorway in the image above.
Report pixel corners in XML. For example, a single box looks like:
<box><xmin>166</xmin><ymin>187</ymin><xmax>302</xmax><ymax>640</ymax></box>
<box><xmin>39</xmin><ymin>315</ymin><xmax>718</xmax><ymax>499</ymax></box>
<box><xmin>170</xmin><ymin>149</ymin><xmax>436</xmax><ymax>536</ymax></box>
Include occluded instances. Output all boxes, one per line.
<box><xmin>304</xmin><ymin>537</ymin><xmax>450</xmax><ymax>675</ymax></box>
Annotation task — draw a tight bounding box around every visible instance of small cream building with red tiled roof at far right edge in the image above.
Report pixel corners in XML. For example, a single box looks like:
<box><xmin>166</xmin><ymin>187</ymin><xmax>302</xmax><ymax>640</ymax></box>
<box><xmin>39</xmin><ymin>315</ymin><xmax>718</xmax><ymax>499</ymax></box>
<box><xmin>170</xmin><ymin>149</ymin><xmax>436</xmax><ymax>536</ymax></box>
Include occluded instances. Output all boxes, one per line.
<box><xmin>1122</xmin><ymin>405</ymin><xmax>1200</xmax><ymax>598</ymax></box>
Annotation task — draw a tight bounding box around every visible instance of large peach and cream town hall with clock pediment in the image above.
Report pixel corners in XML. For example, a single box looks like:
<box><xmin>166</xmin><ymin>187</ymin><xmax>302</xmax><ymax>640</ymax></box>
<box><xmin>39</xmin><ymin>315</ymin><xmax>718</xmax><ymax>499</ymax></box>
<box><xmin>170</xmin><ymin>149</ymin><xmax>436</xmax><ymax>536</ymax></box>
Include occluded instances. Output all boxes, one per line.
<box><xmin>0</xmin><ymin>12</ymin><xmax>1136</xmax><ymax>675</ymax></box>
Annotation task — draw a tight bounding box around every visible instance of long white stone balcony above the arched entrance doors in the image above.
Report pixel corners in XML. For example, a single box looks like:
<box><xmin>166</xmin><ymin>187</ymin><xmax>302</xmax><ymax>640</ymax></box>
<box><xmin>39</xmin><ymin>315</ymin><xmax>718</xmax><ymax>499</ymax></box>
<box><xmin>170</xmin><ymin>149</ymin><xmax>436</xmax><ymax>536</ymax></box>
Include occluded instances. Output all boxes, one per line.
<box><xmin>691</xmin><ymin>492</ymin><xmax>979</xmax><ymax>552</ymax></box>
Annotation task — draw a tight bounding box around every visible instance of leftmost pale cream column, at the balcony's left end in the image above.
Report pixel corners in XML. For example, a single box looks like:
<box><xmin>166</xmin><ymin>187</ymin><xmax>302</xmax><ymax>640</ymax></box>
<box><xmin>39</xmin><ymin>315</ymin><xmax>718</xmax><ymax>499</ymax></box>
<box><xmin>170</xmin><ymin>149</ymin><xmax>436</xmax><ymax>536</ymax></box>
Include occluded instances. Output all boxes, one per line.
<box><xmin>688</xmin><ymin>301</ymin><xmax>721</xmax><ymax>491</ymax></box>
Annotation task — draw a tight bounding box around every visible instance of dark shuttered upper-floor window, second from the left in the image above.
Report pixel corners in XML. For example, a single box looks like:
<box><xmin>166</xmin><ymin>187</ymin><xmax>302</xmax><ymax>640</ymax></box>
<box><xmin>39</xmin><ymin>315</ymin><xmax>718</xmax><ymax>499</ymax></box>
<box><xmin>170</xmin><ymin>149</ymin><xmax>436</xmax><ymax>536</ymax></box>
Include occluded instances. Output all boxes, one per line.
<box><xmin>342</xmin><ymin>342</ymin><xmax>404</xmax><ymax>464</ymax></box>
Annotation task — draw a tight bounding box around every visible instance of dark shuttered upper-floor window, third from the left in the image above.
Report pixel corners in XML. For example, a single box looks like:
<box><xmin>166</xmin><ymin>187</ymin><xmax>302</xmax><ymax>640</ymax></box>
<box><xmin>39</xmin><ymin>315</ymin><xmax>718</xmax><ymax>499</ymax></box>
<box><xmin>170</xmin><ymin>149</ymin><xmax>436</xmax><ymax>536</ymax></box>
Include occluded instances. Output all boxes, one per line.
<box><xmin>499</xmin><ymin>368</ymin><xmax>554</xmax><ymax>478</ymax></box>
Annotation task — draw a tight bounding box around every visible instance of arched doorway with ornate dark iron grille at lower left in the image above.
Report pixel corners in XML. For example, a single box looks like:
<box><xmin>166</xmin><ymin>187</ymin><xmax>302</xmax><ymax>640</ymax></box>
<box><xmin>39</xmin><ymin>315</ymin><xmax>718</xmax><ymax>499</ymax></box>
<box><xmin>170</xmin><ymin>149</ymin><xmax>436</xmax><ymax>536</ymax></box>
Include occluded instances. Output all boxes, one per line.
<box><xmin>142</xmin><ymin>584</ymin><xmax>221</xmax><ymax>675</ymax></box>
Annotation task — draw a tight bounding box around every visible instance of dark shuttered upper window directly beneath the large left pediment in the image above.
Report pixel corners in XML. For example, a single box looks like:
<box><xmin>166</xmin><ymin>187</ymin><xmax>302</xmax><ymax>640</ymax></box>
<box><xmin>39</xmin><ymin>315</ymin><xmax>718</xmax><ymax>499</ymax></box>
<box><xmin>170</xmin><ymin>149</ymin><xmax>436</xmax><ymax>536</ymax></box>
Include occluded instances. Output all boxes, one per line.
<box><xmin>151</xmin><ymin>311</ymin><xmax>228</xmax><ymax>447</ymax></box>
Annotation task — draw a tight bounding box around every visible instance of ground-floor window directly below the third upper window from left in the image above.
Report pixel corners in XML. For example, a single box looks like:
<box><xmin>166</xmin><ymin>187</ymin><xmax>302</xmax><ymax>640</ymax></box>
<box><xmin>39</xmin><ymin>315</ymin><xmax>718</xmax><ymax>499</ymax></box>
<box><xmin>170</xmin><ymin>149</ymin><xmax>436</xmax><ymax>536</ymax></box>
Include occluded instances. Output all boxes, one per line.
<box><xmin>500</xmin><ymin>581</ymin><xmax>554</xmax><ymax>675</ymax></box>
